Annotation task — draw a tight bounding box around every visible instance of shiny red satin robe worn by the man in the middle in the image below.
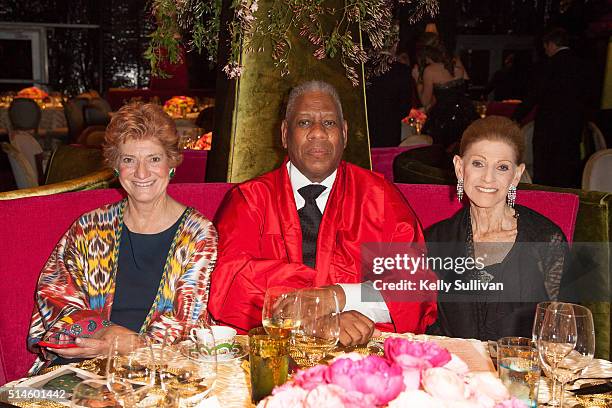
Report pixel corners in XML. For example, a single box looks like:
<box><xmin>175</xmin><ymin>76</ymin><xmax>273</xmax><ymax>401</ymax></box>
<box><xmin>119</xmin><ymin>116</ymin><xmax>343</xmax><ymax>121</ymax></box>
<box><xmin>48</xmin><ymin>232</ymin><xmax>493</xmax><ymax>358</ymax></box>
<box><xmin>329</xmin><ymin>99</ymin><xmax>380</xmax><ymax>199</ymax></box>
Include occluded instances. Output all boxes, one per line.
<box><xmin>208</xmin><ymin>160</ymin><xmax>437</xmax><ymax>333</ymax></box>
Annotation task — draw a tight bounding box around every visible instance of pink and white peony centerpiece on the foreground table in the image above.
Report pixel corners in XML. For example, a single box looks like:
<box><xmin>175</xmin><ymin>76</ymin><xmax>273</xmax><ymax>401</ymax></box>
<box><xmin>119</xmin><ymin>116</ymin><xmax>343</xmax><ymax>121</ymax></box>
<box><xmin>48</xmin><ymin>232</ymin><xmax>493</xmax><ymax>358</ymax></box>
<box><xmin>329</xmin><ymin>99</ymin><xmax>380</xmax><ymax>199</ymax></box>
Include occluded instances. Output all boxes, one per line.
<box><xmin>258</xmin><ymin>338</ymin><xmax>526</xmax><ymax>408</ymax></box>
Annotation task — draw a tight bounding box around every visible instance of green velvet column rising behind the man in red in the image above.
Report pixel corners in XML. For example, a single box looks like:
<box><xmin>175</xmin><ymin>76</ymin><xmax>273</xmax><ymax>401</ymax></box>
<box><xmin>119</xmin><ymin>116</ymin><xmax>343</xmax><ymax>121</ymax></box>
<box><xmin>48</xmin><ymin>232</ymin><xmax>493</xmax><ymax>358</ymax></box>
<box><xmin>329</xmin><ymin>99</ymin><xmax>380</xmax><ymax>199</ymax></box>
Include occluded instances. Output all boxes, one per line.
<box><xmin>206</xmin><ymin>0</ymin><xmax>371</xmax><ymax>183</ymax></box>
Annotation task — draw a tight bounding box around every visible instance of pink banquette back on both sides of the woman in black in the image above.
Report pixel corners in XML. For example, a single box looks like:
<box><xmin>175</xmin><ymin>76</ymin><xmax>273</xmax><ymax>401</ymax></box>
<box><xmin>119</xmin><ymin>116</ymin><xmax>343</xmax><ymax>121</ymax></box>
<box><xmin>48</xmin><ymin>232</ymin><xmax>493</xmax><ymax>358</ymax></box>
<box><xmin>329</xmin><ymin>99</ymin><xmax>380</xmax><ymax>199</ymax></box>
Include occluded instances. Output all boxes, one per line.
<box><xmin>396</xmin><ymin>184</ymin><xmax>578</xmax><ymax>243</ymax></box>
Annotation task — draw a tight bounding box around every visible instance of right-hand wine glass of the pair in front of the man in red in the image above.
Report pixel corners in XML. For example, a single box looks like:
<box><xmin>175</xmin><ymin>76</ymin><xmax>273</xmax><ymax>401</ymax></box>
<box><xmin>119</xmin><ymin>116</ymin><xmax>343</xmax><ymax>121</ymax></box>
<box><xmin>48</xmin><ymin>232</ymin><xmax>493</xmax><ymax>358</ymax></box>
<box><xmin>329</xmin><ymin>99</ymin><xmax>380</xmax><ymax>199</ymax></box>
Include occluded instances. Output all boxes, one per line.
<box><xmin>294</xmin><ymin>288</ymin><xmax>340</xmax><ymax>365</ymax></box>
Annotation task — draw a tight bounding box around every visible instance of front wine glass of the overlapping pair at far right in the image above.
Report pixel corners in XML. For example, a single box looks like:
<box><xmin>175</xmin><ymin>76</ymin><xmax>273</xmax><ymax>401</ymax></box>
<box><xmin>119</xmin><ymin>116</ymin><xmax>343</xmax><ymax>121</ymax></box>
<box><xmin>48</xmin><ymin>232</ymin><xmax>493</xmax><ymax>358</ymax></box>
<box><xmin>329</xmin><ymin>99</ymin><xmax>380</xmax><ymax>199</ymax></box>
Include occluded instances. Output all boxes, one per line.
<box><xmin>537</xmin><ymin>302</ymin><xmax>577</xmax><ymax>406</ymax></box>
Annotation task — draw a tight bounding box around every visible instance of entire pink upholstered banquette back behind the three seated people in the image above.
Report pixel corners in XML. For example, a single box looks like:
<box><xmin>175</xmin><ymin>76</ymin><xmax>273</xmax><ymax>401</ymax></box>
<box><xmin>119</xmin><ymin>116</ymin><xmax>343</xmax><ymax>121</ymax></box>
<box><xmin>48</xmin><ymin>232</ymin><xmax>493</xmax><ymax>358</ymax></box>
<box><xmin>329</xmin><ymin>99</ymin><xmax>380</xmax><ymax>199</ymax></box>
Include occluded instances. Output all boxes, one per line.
<box><xmin>0</xmin><ymin>183</ymin><xmax>578</xmax><ymax>385</ymax></box>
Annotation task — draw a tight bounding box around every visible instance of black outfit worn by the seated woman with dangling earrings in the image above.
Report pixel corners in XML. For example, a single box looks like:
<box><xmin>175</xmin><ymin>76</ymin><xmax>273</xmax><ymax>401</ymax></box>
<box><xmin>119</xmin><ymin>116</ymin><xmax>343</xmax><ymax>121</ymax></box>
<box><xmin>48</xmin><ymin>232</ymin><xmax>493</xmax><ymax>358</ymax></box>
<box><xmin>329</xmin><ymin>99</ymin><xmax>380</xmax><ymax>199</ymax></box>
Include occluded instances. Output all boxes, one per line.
<box><xmin>425</xmin><ymin>205</ymin><xmax>568</xmax><ymax>340</ymax></box>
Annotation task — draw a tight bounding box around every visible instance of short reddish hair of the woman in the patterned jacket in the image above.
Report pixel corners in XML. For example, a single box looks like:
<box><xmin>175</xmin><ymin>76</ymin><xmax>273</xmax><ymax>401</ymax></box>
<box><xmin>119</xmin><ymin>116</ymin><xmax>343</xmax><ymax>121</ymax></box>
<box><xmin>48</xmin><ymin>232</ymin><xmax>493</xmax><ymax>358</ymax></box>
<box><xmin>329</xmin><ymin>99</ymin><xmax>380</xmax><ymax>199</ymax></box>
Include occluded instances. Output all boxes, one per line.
<box><xmin>104</xmin><ymin>102</ymin><xmax>183</xmax><ymax>168</ymax></box>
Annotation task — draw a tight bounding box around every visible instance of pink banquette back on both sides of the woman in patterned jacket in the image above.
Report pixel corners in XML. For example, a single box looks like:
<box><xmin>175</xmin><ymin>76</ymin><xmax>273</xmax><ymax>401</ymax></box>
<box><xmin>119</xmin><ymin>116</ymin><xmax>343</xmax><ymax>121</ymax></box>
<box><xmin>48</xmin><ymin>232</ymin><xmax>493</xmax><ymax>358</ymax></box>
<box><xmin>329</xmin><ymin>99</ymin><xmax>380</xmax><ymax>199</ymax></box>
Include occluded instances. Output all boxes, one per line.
<box><xmin>0</xmin><ymin>183</ymin><xmax>231</xmax><ymax>385</ymax></box>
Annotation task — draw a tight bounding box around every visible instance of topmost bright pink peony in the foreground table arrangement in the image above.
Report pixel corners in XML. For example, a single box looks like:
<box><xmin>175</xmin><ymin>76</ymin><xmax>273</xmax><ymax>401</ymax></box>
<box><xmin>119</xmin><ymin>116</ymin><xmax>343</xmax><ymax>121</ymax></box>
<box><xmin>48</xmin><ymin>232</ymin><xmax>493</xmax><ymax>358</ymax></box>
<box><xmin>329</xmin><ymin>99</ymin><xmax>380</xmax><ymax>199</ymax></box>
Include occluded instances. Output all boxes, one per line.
<box><xmin>385</xmin><ymin>337</ymin><xmax>451</xmax><ymax>370</ymax></box>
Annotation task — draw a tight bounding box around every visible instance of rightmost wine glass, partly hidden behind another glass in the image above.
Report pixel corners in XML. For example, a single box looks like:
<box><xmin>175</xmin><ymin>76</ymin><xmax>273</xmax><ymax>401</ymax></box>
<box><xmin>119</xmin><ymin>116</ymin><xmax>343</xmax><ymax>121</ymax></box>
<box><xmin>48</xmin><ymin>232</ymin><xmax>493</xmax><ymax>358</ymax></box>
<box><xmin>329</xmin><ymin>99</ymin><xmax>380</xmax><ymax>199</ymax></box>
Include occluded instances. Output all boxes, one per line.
<box><xmin>554</xmin><ymin>304</ymin><xmax>595</xmax><ymax>407</ymax></box>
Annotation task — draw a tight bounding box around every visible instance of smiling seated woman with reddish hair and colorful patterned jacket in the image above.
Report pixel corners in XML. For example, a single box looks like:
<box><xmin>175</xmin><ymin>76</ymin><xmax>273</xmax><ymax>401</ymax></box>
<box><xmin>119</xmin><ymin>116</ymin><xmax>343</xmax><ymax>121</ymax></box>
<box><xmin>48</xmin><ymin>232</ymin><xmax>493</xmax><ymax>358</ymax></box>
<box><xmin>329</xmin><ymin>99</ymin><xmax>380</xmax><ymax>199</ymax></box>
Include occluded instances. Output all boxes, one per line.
<box><xmin>28</xmin><ymin>103</ymin><xmax>217</xmax><ymax>373</ymax></box>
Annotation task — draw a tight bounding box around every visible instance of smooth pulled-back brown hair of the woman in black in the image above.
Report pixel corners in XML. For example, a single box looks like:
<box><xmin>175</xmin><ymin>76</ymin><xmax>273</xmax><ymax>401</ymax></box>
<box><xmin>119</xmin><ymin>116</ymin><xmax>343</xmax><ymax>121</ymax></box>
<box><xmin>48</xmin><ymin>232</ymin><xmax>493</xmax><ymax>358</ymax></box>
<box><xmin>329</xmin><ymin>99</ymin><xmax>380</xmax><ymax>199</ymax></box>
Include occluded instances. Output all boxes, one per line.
<box><xmin>459</xmin><ymin>116</ymin><xmax>525</xmax><ymax>164</ymax></box>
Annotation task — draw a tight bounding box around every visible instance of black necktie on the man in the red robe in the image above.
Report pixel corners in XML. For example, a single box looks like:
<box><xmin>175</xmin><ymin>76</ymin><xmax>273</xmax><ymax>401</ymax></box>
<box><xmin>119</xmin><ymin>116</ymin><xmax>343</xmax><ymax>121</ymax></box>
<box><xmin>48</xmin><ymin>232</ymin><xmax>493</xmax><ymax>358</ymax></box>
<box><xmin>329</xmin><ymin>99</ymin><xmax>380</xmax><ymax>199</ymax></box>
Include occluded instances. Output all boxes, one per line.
<box><xmin>298</xmin><ymin>184</ymin><xmax>326</xmax><ymax>268</ymax></box>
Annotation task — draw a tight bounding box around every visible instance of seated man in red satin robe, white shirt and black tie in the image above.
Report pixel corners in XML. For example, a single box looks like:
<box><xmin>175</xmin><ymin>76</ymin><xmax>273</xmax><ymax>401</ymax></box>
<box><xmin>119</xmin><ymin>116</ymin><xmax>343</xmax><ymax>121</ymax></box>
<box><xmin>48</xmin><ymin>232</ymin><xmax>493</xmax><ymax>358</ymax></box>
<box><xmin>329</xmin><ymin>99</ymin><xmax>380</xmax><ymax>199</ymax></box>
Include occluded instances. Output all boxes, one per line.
<box><xmin>208</xmin><ymin>81</ymin><xmax>436</xmax><ymax>345</ymax></box>
